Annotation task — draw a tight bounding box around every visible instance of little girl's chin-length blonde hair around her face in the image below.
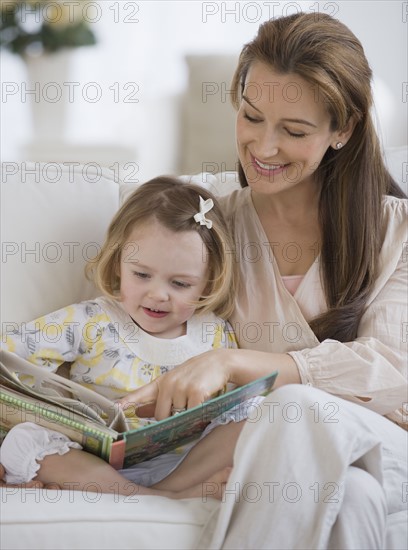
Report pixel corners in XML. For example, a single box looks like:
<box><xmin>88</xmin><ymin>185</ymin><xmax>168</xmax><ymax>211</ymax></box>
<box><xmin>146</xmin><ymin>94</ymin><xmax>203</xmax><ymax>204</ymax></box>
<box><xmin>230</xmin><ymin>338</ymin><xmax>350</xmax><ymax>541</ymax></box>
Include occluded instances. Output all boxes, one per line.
<box><xmin>86</xmin><ymin>176</ymin><xmax>236</xmax><ymax>319</ymax></box>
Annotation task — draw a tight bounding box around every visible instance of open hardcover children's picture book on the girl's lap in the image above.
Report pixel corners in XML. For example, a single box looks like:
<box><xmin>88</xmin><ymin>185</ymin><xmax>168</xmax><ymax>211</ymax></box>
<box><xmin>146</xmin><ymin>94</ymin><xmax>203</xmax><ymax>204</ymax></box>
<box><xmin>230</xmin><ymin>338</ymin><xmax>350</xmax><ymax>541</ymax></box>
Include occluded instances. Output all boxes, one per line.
<box><xmin>0</xmin><ymin>350</ymin><xmax>277</xmax><ymax>469</ymax></box>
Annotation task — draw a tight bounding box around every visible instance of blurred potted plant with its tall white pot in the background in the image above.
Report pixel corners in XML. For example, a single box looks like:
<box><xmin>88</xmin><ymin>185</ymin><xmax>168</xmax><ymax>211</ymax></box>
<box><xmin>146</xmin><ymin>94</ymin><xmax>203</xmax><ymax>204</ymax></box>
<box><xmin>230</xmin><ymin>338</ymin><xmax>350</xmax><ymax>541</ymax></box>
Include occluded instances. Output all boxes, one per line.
<box><xmin>0</xmin><ymin>0</ymin><xmax>98</xmax><ymax>144</ymax></box>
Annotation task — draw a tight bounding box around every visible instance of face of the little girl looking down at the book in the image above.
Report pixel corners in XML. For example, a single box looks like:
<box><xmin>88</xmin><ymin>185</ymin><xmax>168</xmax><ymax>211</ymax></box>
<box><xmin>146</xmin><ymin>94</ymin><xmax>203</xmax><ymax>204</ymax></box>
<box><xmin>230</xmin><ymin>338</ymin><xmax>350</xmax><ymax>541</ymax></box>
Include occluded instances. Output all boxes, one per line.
<box><xmin>120</xmin><ymin>219</ymin><xmax>208</xmax><ymax>338</ymax></box>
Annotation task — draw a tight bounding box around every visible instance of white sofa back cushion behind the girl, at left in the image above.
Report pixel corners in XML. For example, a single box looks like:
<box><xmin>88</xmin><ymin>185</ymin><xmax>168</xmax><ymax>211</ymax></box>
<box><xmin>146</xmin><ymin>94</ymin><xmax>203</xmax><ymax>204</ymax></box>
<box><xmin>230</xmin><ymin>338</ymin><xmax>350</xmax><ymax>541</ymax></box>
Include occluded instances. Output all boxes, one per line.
<box><xmin>0</xmin><ymin>162</ymin><xmax>119</xmax><ymax>332</ymax></box>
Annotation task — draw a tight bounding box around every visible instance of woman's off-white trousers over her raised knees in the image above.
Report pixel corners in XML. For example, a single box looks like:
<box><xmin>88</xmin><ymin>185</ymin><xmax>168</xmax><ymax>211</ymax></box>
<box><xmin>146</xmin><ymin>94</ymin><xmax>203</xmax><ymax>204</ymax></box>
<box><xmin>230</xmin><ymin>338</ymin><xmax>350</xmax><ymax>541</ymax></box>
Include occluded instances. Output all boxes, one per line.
<box><xmin>199</xmin><ymin>385</ymin><xmax>408</xmax><ymax>550</ymax></box>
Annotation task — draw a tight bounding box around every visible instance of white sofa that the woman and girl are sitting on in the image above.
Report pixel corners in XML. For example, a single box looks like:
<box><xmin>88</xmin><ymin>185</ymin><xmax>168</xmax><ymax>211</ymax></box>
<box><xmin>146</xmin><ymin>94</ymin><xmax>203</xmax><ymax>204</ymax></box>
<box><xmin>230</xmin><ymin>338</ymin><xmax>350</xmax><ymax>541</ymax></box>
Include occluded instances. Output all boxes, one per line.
<box><xmin>0</xmin><ymin>148</ymin><xmax>407</xmax><ymax>550</ymax></box>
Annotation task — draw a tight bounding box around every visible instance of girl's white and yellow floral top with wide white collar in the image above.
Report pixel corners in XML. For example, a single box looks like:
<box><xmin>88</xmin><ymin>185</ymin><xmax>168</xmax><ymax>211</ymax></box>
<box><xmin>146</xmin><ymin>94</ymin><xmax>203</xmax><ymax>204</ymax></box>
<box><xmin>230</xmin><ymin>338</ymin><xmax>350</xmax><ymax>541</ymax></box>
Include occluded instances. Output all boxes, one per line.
<box><xmin>1</xmin><ymin>297</ymin><xmax>236</xmax><ymax>427</ymax></box>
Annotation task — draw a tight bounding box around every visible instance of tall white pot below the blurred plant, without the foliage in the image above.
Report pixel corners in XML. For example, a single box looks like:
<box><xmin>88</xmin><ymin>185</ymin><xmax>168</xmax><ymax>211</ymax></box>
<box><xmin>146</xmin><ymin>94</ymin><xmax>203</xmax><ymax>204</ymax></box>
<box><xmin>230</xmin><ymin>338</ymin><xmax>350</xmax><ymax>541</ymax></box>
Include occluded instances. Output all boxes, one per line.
<box><xmin>24</xmin><ymin>49</ymin><xmax>72</xmax><ymax>142</ymax></box>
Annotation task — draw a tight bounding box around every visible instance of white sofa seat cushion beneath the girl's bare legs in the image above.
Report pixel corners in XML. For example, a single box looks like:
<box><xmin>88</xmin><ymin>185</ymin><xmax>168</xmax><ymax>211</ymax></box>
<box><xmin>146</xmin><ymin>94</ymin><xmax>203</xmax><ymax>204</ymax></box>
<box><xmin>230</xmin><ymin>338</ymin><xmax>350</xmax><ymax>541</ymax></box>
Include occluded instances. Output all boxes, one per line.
<box><xmin>0</xmin><ymin>487</ymin><xmax>219</xmax><ymax>550</ymax></box>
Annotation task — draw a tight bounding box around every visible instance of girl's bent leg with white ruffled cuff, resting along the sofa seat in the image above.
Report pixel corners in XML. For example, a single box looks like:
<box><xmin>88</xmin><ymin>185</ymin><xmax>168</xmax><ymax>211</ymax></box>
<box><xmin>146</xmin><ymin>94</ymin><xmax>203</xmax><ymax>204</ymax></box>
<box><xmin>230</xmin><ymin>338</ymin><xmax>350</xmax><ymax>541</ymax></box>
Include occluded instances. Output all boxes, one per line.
<box><xmin>0</xmin><ymin>422</ymin><xmax>229</xmax><ymax>498</ymax></box>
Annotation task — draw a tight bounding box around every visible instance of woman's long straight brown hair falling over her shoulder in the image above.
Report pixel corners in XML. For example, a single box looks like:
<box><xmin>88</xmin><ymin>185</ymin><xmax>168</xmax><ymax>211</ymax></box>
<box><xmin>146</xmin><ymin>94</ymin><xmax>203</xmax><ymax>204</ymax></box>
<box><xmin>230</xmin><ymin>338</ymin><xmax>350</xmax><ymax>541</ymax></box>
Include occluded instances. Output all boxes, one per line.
<box><xmin>232</xmin><ymin>13</ymin><xmax>405</xmax><ymax>342</ymax></box>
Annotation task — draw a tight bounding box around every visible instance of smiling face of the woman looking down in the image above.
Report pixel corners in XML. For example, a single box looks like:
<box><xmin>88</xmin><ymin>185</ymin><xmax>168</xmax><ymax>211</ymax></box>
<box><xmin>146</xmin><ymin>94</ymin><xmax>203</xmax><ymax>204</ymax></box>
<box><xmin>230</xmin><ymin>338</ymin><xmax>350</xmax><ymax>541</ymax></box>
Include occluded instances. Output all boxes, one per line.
<box><xmin>236</xmin><ymin>62</ymin><xmax>339</xmax><ymax>195</ymax></box>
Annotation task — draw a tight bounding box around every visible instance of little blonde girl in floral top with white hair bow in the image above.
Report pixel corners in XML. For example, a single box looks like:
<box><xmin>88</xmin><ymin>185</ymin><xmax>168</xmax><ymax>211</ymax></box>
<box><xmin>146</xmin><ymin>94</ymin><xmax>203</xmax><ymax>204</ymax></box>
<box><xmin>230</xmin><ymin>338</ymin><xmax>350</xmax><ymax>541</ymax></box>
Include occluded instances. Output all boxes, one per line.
<box><xmin>0</xmin><ymin>177</ymin><xmax>247</xmax><ymax>498</ymax></box>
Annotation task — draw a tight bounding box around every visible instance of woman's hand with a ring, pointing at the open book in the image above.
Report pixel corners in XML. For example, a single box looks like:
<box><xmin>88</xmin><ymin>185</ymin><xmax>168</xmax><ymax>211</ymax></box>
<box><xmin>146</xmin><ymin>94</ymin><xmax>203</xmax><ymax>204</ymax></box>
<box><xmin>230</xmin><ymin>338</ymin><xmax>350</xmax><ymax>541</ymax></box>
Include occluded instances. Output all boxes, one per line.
<box><xmin>119</xmin><ymin>349</ymin><xmax>231</xmax><ymax>420</ymax></box>
